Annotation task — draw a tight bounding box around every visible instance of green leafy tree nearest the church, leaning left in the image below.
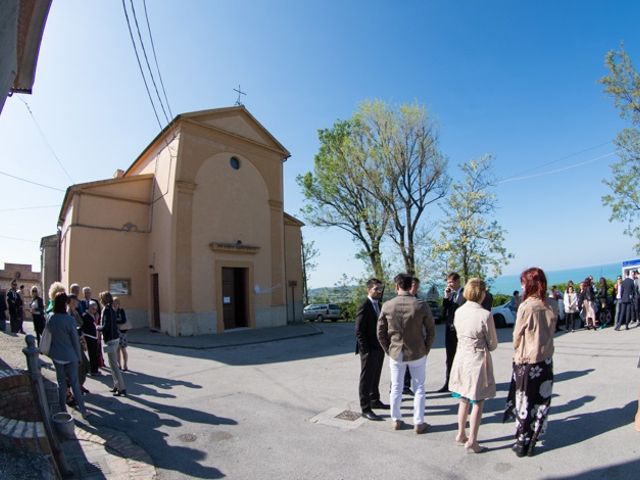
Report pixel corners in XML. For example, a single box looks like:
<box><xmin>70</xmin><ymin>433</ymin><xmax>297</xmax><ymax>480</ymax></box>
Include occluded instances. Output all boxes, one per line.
<box><xmin>296</xmin><ymin>120</ymin><xmax>389</xmax><ymax>278</ymax></box>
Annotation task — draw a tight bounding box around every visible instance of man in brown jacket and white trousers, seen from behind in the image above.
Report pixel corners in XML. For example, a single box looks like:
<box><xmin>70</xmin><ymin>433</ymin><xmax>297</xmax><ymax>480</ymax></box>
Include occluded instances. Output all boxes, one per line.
<box><xmin>378</xmin><ymin>273</ymin><xmax>435</xmax><ymax>433</ymax></box>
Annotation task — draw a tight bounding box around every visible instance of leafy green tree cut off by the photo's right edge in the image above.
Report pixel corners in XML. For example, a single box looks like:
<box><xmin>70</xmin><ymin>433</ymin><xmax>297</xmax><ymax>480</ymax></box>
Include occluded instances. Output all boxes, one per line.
<box><xmin>600</xmin><ymin>46</ymin><xmax>640</xmax><ymax>253</ymax></box>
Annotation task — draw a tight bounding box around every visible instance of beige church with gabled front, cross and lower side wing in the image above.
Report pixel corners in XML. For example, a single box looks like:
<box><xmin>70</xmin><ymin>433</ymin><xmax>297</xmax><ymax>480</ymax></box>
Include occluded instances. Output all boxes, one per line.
<box><xmin>44</xmin><ymin>106</ymin><xmax>303</xmax><ymax>336</ymax></box>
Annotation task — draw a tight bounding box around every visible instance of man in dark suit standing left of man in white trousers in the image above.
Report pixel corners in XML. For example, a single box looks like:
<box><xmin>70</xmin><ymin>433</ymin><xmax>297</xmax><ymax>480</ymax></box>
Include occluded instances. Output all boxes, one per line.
<box><xmin>356</xmin><ymin>278</ymin><xmax>389</xmax><ymax>420</ymax></box>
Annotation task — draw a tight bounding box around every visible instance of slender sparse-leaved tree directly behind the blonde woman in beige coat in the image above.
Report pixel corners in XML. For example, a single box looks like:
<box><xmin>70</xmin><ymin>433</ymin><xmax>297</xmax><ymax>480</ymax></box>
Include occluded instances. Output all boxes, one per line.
<box><xmin>432</xmin><ymin>155</ymin><xmax>513</xmax><ymax>282</ymax></box>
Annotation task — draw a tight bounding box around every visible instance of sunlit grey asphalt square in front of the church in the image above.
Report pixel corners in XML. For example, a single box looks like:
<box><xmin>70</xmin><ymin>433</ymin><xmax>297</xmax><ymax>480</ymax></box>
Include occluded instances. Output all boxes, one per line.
<box><xmin>77</xmin><ymin>323</ymin><xmax>640</xmax><ymax>480</ymax></box>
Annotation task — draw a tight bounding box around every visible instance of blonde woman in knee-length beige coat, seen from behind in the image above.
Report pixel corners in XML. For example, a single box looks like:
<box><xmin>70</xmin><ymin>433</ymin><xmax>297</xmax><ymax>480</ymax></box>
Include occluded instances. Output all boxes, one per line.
<box><xmin>449</xmin><ymin>278</ymin><xmax>498</xmax><ymax>453</ymax></box>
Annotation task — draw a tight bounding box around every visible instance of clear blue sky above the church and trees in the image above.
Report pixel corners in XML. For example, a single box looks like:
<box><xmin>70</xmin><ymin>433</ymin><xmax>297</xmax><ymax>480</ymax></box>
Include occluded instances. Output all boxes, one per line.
<box><xmin>0</xmin><ymin>0</ymin><xmax>640</xmax><ymax>287</ymax></box>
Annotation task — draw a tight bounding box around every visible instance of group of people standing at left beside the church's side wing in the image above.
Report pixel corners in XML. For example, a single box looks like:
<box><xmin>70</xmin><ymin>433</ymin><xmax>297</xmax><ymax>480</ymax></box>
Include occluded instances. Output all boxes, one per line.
<box><xmin>7</xmin><ymin>282</ymin><xmax>131</xmax><ymax>417</ymax></box>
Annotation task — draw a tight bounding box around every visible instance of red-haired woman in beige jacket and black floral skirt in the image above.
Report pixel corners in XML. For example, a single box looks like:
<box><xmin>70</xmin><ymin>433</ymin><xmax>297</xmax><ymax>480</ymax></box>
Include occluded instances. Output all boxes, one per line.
<box><xmin>504</xmin><ymin>267</ymin><xmax>556</xmax><ymax>457</ymax></box>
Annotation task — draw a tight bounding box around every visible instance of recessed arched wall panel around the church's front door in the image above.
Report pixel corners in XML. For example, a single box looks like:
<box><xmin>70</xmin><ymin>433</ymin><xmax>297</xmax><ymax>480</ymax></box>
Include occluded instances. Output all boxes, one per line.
<box><xmin>191</xmin><ymin>153</ymin><xmax>272</xmax><ymax>331</ymax></box>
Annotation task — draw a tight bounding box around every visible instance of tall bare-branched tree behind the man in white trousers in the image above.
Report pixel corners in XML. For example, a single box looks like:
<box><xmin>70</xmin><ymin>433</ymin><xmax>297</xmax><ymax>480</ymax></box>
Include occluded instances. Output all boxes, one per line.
<box><xmin>354</xmin><ymin>100</ymin><xmax>450</xmax><ymax>275</ymax></box>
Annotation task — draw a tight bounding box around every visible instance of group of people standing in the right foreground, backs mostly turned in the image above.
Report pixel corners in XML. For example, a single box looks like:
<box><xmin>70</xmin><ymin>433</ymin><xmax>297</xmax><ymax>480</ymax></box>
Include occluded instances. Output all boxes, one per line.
<box><xmin>356</xmin><ymin>268</ymin><xmax>557</xmax><ymax>457</ymax></box>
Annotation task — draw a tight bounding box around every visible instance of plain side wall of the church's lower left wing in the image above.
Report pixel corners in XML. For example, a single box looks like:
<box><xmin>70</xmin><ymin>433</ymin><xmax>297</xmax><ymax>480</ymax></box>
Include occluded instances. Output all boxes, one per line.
<box><xmin>61</xmin><ymin>176</ymin><xmax>153</xmax><ymax>327</ymax></box>
